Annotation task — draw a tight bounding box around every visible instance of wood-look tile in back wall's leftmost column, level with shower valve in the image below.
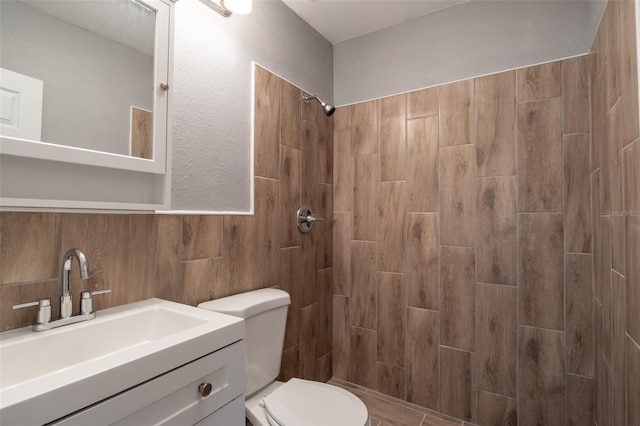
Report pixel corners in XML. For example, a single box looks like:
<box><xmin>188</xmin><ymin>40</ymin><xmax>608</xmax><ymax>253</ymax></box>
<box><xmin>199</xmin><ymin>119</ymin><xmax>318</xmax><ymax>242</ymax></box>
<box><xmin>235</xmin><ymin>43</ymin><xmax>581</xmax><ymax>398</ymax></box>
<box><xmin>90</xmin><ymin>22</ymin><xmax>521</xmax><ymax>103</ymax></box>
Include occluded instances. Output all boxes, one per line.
<box><xmin>333</xmin><ymin>213</ymin><xmax>351</xmax><ymax>296</ymax></box>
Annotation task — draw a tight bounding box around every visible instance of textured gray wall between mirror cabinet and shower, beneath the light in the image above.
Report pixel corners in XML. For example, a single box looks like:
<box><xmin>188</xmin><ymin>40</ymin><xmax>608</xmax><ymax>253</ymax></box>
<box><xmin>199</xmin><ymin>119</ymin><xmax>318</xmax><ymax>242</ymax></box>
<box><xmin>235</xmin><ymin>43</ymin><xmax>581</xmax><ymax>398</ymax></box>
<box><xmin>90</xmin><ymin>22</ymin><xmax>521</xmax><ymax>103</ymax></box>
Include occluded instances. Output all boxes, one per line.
<box><xmin>171</xmin><ymin>0</ymin><xmax>333</xmax><ymax>212</ymax></box>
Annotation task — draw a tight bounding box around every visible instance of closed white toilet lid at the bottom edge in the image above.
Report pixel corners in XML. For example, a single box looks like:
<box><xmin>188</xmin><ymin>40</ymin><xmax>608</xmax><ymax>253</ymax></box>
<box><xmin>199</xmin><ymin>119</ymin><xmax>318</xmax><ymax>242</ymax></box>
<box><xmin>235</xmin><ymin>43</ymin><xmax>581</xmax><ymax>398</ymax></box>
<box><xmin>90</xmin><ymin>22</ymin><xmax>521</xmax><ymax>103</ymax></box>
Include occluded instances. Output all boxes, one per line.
<box><xmin>263</xmin><ymin>379</ymin><xmax>369</xmax><ymax>426</ymax></box>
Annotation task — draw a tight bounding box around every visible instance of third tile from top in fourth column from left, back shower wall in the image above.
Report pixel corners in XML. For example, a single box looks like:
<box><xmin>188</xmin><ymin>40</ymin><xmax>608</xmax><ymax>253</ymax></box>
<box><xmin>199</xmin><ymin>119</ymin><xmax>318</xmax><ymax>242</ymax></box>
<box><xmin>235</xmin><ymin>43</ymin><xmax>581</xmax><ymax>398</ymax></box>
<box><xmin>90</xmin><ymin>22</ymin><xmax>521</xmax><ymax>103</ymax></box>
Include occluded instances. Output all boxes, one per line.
<box><xmin>407</xmin><ymin>214</ymin><xmax>440</xmax><ymax>310</ymax></box>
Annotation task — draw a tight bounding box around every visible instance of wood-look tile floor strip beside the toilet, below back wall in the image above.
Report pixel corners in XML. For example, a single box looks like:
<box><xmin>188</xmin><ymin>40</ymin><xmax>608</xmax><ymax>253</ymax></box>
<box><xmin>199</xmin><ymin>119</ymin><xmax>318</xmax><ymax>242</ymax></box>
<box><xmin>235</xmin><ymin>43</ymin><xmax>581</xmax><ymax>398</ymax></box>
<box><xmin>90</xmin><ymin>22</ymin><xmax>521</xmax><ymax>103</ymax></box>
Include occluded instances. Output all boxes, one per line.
<box><xmin>329</xmin><ymin>378</ymin><xmax>473</xmax><ymax>426</ymax></box>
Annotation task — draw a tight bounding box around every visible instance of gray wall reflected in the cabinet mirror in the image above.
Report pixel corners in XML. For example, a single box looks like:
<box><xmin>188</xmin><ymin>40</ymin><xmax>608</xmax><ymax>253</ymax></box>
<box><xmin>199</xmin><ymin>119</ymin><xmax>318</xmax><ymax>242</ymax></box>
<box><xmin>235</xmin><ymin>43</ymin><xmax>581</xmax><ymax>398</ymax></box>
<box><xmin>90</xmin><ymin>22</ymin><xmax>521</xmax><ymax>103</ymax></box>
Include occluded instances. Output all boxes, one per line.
<box><xmin>0</xmin><ymin>0</ymin><xmax>153</xmax><ymax>155</ymax></box>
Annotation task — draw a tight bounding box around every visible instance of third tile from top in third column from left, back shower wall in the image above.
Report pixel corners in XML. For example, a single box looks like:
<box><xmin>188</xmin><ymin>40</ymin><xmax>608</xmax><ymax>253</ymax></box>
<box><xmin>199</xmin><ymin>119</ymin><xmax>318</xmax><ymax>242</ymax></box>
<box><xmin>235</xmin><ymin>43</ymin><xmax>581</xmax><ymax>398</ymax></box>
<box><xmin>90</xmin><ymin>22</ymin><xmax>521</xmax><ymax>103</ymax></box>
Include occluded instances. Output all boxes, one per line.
<box><xmin>376</xmin><ymin>272</ymin><xmax>407</xmax><ymax>367</ymax></box>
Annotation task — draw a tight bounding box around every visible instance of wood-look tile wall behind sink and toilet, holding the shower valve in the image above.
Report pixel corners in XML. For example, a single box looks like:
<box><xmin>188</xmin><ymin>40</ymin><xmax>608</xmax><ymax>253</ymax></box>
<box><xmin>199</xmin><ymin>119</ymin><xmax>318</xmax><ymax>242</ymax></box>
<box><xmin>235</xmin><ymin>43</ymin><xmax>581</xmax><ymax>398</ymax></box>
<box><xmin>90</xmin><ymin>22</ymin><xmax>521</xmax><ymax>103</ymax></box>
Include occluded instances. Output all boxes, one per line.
<box><xmin>0</xmin><ymin>67</ymin><xmax>333</xmax><ymax>381</ymax></box>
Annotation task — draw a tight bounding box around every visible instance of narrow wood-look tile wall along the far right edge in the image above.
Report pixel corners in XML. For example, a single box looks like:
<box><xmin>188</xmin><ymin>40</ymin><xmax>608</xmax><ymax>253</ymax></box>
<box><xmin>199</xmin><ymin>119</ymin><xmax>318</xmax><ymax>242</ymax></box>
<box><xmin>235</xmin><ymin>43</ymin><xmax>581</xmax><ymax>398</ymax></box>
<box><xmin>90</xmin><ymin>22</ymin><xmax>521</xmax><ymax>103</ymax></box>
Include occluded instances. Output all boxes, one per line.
<box><xmin>592</xmin><ymin>0</ymin><xmax>640</xmax><ymax>426</ymax></box>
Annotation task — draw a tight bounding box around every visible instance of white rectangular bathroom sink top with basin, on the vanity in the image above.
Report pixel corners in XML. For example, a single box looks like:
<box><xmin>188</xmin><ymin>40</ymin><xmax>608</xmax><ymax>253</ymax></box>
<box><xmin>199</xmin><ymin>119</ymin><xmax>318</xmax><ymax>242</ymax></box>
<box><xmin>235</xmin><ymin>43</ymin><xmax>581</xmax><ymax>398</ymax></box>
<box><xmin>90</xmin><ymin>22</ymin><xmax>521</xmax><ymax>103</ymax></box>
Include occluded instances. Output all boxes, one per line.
<box><xmin>0</xmin><ymin>299</ymin><xmax>244</xmax><ymax>424</ymax></box>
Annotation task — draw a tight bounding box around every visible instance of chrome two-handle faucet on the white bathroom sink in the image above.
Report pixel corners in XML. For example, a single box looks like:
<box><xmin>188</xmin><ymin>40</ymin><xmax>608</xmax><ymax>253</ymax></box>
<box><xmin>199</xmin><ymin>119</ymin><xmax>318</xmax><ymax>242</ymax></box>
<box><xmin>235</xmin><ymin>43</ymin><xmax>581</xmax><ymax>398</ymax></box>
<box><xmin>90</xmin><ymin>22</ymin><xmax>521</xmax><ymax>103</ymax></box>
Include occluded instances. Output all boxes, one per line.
<box><xmin>13</xmin><ymin>248</ymin><xmax>111</xmax><ymax>331</ymax></box>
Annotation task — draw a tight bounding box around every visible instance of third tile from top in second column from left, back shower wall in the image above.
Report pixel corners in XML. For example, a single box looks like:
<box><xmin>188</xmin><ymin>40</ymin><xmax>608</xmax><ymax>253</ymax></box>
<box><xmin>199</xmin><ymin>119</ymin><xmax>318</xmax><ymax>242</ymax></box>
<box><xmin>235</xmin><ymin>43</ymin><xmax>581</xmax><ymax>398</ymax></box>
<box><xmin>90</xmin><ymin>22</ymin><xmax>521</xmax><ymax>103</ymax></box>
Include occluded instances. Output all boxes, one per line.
<box><xmin>349</xmin><ymin>241</ymin><xmax>377</xmax><ymax>330</ymax></box>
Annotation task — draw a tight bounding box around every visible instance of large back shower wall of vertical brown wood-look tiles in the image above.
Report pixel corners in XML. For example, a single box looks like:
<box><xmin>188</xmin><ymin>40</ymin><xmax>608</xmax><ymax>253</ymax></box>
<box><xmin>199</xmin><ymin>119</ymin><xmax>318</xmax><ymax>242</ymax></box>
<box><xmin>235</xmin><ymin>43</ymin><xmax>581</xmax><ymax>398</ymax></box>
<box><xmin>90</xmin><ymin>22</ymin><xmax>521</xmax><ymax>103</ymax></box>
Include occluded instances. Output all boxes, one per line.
<box><xmin>333</xmin><ymin>56</ymin><xmax>596</xmax><ymax>425</ymax></box>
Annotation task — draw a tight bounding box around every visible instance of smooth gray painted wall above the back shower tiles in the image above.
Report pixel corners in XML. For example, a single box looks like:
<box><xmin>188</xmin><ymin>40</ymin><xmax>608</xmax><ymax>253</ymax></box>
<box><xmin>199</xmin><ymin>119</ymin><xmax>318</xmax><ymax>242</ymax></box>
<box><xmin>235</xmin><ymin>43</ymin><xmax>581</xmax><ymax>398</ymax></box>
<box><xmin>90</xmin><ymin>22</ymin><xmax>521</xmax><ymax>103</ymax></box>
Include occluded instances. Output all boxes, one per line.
<box><xmin>333</xmin><ymin>0</ymin><xmax>605</xmax><ymax>105</ymax></box>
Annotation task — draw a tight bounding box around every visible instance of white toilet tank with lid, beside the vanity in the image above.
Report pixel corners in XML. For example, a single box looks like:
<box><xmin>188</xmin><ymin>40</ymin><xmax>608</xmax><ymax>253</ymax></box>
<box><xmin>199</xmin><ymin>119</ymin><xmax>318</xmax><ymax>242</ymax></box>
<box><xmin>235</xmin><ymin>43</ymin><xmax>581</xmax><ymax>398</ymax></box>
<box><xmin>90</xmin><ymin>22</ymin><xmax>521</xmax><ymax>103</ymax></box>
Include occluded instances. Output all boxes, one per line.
<box><xmin>198</xmin><ymin>288</ymin><xmax>291</xmax><ymax>397</ymax></box>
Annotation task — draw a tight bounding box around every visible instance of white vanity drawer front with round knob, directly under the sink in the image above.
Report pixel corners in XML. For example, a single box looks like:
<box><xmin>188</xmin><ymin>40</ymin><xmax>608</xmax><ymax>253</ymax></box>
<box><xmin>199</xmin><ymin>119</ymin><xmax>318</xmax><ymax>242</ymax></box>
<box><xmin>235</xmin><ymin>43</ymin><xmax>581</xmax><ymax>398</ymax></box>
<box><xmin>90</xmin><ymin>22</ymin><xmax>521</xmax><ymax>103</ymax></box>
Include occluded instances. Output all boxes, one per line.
<box><xmin>54</xmin><ymin>341</ymin><xmax>244</xmax><ymax>426</ymax></box>
